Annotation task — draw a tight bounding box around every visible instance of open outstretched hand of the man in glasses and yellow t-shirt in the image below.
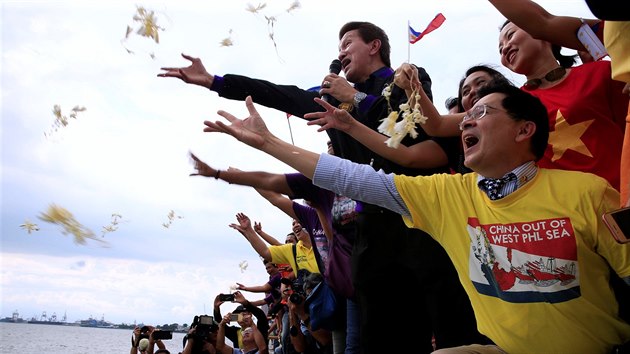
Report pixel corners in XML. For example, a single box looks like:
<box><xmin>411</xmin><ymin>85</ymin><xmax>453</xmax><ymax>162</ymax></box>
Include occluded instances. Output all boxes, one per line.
<box><xmin>203</xmin><ymin>96</ymin><xmax>273</xmax><ymax>150</ymax></box>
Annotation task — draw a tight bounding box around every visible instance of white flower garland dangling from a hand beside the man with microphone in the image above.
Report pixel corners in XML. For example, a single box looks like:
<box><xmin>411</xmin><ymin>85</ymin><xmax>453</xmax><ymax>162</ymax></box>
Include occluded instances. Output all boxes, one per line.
<box><xmin>378</xmin><ymin>83</ymin><xmax>427</xmax><ymax>148</ymax></box>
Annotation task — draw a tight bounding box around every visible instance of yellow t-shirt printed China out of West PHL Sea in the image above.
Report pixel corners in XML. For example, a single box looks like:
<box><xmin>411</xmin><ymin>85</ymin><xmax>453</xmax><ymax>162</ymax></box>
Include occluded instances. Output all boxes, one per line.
<box><xmin>394</xmin><ymin>169</ymin><xmax>630</xmax><ymax>354</ymax></box>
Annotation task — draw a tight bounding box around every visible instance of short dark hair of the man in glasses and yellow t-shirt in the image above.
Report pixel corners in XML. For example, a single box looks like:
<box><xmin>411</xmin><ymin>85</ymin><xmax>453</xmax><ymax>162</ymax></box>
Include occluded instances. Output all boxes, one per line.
<box><xmin>478</xmin><ymin>84</ymin><xmax>549</xmax><ymax>160</ymax></box>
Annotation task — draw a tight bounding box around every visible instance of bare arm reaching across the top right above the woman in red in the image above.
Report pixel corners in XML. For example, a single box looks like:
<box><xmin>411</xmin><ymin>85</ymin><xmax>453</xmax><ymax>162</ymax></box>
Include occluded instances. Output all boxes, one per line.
<box><xmin>488</xmin><ymin>0</ymin><xmax>600</xmax><ymax>51</ymax></box>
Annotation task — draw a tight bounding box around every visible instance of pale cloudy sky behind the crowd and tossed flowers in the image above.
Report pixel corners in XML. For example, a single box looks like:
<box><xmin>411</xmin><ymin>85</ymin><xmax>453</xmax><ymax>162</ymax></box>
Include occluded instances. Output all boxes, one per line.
<box><xmin>0</xmin><ymin>0</ymin><xmax>593</xmax><ymax>325</ymax></box>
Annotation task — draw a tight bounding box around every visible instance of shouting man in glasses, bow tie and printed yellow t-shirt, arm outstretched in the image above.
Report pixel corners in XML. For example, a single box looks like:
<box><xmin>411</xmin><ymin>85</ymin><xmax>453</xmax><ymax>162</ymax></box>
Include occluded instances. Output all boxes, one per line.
<box><xmin>204</xmin><ymin>85</ymin><xmax>630</xmax><ymax>354</ymax></box>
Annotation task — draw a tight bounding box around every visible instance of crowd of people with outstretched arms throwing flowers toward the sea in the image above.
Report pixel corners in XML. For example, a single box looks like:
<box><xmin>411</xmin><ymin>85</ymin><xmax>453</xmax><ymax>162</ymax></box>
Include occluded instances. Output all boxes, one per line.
<box><xmin>144</xmin><ymin>0</ymin><xmax>630</xmax><ymax>354</ymax></box>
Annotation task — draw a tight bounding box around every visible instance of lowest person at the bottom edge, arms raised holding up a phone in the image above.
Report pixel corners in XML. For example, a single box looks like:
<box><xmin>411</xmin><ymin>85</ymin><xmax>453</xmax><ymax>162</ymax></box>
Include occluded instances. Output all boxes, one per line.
<box><xmin>216</xmin><ymin>312</ymin><xmax>269</xmax><ymax>354</ymax></box>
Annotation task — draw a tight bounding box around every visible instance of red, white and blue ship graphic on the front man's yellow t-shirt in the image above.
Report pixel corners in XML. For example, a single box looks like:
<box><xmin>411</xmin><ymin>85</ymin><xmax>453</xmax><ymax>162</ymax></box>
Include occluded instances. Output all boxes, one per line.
<box><xmin>467</xmin><ymin>218</ymin><xmax>580</xmax><ymax>303</ymax></box>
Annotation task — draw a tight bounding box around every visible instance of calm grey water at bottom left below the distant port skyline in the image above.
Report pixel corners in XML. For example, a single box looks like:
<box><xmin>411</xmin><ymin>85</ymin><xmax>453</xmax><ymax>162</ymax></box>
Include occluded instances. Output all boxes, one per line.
<box><xmin>0</xmin><ymin>322</ymin><xmax>184</xmax><ymax>354</ymax></box>
